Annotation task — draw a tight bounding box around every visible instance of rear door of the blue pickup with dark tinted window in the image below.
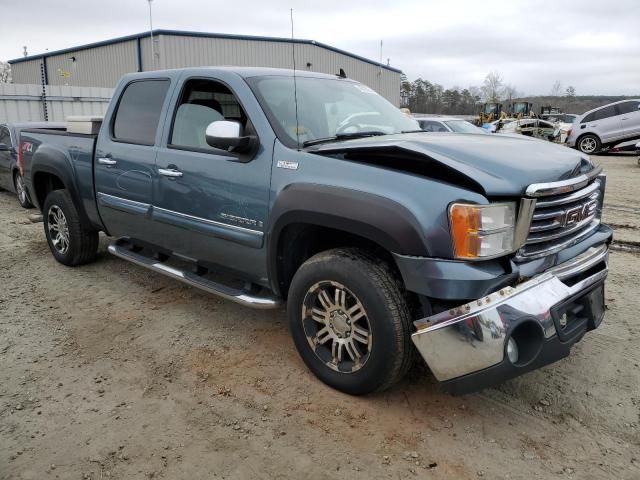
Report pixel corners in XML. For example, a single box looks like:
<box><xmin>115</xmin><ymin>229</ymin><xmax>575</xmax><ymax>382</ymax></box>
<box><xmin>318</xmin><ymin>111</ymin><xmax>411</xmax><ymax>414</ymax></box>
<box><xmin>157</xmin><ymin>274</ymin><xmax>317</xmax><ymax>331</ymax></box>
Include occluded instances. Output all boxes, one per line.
<box><xmin>94</xmin><ymin>77</ymin><xmax>171</xmax><ymax>243</ymax></box>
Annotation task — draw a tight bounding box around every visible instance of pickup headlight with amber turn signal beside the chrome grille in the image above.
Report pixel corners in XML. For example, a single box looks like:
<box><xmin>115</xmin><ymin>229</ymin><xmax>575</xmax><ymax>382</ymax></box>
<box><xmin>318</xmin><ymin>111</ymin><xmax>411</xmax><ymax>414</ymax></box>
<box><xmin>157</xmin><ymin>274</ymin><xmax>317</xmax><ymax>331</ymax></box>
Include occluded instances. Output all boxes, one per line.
<box><xmin>449</xmin><ymin>203</ymin><xmax>516</xmax><ymax>260</ymax></box>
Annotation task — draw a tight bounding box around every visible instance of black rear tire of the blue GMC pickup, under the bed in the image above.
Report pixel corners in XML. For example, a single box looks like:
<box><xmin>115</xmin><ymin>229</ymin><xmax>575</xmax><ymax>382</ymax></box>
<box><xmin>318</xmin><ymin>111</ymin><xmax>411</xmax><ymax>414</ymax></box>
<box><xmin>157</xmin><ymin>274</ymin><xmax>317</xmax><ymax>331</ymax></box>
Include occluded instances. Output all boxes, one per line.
<box><xmin>42</xmin><ymin>190</ymin><xmax>98</xmax><ymax>267</ymax></box>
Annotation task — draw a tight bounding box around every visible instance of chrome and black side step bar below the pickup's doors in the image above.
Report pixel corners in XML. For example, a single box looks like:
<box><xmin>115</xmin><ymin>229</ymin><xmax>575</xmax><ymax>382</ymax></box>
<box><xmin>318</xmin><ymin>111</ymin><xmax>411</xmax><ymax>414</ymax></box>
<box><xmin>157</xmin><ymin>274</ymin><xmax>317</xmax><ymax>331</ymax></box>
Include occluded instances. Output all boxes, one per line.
<box><xmin>109</xmin><ymin>239</ymin><xmax>282</xmax><ymax>310</ymax></box>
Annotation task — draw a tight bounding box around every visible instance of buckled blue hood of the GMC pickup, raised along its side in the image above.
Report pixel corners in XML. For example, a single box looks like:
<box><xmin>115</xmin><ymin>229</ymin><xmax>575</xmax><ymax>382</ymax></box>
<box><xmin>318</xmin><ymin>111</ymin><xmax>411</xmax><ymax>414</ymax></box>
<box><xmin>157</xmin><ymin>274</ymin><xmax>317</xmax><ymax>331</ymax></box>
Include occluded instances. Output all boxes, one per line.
<box><xmin>306</xmin><ymin>132</ymin><xmax>594</xmax><ymax>197</ymax></box>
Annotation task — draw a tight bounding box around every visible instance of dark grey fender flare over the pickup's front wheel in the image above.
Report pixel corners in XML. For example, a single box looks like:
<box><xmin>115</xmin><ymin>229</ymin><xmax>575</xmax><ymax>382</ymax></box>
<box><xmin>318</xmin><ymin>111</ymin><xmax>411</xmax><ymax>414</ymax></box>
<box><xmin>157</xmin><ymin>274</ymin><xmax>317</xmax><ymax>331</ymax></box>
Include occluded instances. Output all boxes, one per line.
<box><xmin>267</xmin><ymin>183</ymin><xmax>428</xmax><ymax>292</ymax></box>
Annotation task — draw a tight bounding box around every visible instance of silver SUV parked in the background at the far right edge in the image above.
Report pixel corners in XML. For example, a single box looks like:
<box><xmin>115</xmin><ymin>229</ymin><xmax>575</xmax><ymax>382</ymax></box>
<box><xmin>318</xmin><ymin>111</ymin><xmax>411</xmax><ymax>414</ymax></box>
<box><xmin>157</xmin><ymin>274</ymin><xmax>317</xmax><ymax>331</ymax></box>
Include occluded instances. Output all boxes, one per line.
<box><xmin>567</xmin><ymin>100</ymin><xmax>640</xmax><ymax>153</ymax></box>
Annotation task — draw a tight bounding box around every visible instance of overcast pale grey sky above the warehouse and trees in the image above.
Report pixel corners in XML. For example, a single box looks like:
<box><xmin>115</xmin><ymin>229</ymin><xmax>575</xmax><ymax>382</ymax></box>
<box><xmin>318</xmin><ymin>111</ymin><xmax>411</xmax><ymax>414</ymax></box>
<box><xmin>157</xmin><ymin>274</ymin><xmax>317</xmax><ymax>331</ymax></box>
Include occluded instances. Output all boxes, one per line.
<box><xmin>0</xmin><ymin>0</ymin><xmax>640</xmax><ymax>95</ymax></box>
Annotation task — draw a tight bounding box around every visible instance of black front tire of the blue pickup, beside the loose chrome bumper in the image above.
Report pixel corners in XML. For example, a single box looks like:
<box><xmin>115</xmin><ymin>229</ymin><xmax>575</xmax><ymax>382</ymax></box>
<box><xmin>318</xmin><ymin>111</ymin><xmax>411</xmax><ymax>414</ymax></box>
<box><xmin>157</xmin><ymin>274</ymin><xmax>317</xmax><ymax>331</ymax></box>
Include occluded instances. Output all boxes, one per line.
<box><xmin>287</xmin><ymin>249</ymin><xmax>413</xmax><ymax>395</ymax></box>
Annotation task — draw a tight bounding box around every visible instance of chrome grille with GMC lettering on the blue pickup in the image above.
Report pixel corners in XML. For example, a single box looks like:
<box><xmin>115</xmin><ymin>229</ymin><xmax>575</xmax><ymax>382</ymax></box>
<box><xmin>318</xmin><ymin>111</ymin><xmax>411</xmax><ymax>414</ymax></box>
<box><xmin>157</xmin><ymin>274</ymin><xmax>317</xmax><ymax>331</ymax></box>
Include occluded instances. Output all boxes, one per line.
<box><xmin>516</xmin><ymin>177</ymin><xmax>604</xmax><ymax>261</ymax></box>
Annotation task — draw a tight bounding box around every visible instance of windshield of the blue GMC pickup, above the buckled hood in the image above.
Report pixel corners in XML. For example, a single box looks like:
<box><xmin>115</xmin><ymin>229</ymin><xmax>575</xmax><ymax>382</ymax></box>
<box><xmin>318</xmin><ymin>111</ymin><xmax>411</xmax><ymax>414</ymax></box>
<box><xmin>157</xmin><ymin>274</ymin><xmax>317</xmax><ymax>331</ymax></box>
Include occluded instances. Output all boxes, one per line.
<box><xmin>247</xmin><ymin>76</ymin><xmax>420</xmax><ymax>147</ymax></box>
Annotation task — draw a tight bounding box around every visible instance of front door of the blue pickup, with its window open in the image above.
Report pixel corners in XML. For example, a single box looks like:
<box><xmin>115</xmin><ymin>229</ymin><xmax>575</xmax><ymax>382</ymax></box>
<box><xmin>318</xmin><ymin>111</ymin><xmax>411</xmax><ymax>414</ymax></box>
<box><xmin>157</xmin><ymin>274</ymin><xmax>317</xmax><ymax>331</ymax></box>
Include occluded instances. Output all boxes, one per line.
<box><xmin>153</xmin><ymin>78</ymin><xmax>272</xmax><ymax>278</ymax></box>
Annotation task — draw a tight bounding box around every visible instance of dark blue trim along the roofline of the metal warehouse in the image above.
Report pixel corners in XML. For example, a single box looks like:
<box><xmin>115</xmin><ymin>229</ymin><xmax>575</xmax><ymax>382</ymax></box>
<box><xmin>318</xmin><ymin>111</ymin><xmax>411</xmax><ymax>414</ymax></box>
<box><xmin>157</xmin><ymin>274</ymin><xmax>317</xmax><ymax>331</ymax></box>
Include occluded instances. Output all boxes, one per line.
<box><xmin>9</xmin><ymin>29</ymin><xmax>402</xmax><ymax>73</ymax></box>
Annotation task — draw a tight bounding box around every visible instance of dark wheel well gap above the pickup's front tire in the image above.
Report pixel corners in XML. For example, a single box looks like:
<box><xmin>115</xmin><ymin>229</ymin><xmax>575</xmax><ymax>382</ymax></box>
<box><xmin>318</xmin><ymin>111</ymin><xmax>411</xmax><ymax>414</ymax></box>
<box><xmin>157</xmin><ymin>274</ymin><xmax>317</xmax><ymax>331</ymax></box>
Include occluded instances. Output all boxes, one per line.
<box><xmin>276</xmin><ymin>223</ymin><xmax>402</xmax><ymax>298</ymax></box>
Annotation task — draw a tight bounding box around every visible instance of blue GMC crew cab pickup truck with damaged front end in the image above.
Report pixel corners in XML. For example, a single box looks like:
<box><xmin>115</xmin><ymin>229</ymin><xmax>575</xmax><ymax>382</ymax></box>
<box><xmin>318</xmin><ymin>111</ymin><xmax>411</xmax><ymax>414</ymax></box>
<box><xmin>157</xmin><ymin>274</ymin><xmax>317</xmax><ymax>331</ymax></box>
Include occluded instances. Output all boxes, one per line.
<box><xmin>21</xmin><ymin>67</ymin><xmax>612</xmax><ymax>394</ymax></box>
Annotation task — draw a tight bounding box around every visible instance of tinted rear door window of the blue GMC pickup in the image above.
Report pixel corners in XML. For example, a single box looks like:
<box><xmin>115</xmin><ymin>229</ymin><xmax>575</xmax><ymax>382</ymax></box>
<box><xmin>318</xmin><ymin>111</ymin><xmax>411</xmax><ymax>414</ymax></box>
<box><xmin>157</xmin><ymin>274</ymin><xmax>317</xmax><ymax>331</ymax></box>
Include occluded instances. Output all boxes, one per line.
<box><xmin>113</xmin><ymin>80</ymin><xmax>169</xmax><ymax>145</ymax></box>
